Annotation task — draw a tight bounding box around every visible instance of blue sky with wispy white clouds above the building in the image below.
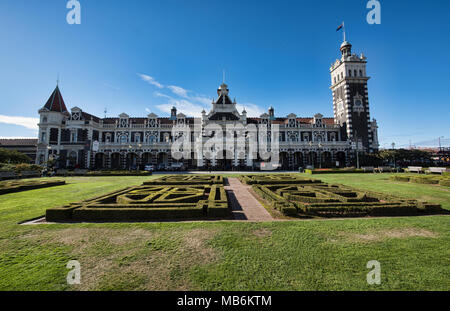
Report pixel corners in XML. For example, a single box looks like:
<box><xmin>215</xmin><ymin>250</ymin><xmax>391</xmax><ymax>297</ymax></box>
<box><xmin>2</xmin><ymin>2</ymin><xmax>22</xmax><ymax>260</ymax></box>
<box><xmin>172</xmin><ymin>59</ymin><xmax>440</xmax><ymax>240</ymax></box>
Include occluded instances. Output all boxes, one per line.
<box><xmin>0</xmin><ymin>0</ymin><xmax>450</xmax><ymax>147</ymax></box>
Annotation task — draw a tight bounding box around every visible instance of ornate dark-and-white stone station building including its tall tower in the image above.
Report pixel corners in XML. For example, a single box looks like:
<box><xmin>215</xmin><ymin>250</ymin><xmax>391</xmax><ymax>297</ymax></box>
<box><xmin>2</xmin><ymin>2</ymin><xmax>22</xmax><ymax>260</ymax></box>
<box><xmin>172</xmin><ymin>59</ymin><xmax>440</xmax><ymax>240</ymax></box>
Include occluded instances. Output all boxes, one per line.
<box><xmin>36</xmin><ymin>42</ymin><xmax>378</xmax><ymax>170</ymax></box>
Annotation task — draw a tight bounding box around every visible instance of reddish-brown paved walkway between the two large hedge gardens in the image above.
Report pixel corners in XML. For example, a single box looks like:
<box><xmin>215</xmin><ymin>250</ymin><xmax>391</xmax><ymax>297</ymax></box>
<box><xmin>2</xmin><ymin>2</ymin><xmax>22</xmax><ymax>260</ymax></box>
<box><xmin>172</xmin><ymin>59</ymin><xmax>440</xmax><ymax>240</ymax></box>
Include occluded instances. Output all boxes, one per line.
<box><xmin>225</xmin><ymin>178</ymin><xmax>273</xmax><ymax>221</ymax></box>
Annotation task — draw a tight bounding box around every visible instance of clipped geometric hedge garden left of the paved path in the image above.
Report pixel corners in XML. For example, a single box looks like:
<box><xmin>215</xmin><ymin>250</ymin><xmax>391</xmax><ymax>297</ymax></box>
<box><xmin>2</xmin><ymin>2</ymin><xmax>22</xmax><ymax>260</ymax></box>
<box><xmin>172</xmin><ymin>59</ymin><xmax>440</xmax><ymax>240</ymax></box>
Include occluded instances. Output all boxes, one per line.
<box><xmin>46</xmin><ymin>175</ymin><xmax>231</xmax><ymax>222</ymax></box>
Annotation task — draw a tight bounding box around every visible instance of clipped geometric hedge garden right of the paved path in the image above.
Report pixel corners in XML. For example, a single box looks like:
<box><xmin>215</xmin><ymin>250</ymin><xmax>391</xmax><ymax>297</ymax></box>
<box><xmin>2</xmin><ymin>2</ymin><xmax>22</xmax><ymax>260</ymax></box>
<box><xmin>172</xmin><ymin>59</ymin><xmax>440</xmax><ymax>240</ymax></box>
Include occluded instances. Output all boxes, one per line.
<box><xmin>246</xmin><ymin>175</ymin><xmax>443</xmax><ymax>217</ymax></box>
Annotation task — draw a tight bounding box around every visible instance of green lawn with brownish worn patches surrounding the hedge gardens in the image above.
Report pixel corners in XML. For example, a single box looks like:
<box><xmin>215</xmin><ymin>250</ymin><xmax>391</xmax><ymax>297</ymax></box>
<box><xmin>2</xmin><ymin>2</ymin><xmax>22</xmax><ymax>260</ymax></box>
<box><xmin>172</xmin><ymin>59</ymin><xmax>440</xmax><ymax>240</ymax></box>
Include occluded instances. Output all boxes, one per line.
<box><xmin>0</xmin><ymin>174</ymin><xmax>450</xmax><ymax>290</ymax></box>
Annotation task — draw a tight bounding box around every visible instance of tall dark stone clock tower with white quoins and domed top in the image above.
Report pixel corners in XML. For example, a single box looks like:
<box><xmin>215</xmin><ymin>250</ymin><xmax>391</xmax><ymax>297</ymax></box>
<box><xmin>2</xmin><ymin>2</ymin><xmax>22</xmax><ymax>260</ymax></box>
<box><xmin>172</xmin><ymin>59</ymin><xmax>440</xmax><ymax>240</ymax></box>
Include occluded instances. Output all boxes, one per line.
<box><xmin>330</xmin><ymin>41</ymin><xmax>378</xmax><ymax>153</ymax></box>
